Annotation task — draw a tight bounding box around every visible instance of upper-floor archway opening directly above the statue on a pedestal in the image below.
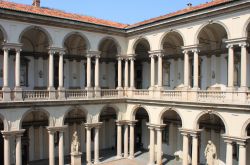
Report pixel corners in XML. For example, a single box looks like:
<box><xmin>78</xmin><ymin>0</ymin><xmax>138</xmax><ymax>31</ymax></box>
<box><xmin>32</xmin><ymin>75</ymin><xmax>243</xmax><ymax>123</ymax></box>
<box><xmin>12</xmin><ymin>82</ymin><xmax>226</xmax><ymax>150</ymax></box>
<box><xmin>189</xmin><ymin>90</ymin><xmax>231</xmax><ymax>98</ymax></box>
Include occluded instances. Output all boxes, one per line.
<box><xmin>63</xmin><ymin>33</ymin><xmax>89</xmax><ymax>89</ymax></box>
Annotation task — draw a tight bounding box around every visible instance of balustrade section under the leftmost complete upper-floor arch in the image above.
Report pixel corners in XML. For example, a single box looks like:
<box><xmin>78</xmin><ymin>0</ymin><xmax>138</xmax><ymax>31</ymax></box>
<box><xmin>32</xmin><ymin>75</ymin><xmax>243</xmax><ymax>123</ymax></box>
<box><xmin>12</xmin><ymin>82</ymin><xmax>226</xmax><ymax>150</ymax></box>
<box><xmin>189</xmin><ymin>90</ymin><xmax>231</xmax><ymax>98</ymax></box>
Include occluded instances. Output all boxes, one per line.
<box><xmin>22</xmin><ymin>90</ymin><xmax>49</xmax><ymax>100</ymax></box>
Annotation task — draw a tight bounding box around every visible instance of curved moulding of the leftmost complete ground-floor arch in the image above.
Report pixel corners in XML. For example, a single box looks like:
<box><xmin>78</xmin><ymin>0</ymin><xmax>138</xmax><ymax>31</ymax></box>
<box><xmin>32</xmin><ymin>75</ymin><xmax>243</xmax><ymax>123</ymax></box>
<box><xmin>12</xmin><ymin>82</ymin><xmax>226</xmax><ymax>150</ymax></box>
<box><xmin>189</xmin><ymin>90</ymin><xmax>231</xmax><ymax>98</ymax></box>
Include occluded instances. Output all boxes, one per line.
<box><xmin>19</xmin><ymin>108</ymin><xmax>51</xmax><ymax>129</ymax></box>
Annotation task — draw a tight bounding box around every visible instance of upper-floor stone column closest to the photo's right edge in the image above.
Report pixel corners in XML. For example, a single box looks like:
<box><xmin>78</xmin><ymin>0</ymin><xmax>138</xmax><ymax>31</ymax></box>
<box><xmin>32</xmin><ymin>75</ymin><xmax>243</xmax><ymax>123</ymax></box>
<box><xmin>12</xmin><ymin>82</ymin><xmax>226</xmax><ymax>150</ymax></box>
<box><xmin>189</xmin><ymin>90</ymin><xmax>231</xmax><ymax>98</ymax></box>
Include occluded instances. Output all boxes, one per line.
<box><xmin>240</xmin><ymin>43</ymin><xmax>248</xmax><ymax>91</ymax></box>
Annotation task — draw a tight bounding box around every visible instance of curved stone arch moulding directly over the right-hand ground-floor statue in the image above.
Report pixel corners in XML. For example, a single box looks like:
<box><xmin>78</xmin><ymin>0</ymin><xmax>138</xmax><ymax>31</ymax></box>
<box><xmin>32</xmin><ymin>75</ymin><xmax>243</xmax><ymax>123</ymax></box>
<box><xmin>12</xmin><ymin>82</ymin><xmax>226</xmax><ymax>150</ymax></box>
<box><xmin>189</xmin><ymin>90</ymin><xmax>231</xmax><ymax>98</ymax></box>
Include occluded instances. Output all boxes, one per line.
<box><xmin>193</xmin><ymin>111</ymin><xmax>229</xmax><ymax>134</ymax></box>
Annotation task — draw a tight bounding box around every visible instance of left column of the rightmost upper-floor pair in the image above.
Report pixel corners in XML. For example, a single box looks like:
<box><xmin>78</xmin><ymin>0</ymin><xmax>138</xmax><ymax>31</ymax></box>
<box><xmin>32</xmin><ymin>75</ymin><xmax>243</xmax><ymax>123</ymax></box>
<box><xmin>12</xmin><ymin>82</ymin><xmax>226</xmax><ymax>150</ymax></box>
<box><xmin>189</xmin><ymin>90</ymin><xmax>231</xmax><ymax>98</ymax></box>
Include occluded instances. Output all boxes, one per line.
<box><xmin>227</xmin><ymin>44</ymin><xmax>234</xmax><ymax>90</ymax></box>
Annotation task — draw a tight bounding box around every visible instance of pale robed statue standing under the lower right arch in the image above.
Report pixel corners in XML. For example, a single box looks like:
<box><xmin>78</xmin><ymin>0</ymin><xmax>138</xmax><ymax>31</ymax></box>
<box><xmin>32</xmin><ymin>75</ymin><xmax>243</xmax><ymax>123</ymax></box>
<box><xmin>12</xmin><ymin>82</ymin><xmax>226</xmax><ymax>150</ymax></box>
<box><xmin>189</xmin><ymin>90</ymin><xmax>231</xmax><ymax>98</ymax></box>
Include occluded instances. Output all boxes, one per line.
<box><xmin>204</xmin><ymin>140</ymin><xmax>217</xmax><ymax>165</ymax></box>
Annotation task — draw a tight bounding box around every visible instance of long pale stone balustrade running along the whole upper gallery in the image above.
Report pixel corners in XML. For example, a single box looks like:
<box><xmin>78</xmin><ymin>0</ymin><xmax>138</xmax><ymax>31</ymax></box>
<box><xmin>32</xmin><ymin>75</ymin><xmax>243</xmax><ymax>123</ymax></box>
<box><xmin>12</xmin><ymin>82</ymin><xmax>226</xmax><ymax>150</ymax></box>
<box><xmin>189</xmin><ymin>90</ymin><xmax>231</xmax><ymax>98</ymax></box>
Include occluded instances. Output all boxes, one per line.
<box><xmin>0</xmin><ymin>89</ymin><xmax>250</xmax><ymax>104</ymax></box>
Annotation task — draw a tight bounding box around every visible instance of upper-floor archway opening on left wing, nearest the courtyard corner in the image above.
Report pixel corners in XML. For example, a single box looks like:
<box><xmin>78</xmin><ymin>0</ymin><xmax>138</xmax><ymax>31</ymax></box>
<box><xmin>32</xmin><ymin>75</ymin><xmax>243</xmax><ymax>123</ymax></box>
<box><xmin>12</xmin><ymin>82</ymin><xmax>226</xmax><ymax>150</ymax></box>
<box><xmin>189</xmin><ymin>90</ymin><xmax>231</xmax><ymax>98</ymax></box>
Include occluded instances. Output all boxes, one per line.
<box><xmin>98</xmin><ymin>37</ymin><xmax>120</xmax><ymax>89</ymax></box>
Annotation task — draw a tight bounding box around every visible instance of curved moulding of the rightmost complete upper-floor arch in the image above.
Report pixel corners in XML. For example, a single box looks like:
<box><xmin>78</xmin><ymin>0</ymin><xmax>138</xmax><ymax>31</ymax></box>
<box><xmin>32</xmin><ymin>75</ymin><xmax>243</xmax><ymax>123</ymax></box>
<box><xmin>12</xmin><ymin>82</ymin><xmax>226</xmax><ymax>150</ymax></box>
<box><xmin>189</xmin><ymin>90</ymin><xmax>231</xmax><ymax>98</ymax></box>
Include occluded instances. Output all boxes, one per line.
<box><xmin>194</xmin><ymin>21</ymin><xmax>231</xmax><ymax>44</ymax></box>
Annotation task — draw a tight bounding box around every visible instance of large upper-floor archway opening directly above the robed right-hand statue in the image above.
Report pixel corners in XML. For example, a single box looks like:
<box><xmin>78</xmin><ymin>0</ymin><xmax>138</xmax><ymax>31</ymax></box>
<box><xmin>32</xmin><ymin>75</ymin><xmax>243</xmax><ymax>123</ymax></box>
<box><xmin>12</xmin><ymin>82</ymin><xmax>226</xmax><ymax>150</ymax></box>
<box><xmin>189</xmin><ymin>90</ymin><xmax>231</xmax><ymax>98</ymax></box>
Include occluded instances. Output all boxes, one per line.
<box><xmin>197</xmin><ymin>23</ymin><xmax>229</xmax><ymax>90</ymax></box>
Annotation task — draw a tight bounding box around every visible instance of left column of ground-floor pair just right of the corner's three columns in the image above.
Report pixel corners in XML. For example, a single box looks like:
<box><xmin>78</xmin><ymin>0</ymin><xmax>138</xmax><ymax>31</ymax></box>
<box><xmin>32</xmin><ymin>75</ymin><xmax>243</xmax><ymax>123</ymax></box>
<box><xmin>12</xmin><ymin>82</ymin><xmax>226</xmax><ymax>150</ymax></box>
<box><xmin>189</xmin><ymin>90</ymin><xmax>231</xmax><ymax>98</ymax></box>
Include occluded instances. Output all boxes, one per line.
<box><xmin>148</xmin><ymin>126</ymin><xmax>155</xmax><ymax>165</ymax></box>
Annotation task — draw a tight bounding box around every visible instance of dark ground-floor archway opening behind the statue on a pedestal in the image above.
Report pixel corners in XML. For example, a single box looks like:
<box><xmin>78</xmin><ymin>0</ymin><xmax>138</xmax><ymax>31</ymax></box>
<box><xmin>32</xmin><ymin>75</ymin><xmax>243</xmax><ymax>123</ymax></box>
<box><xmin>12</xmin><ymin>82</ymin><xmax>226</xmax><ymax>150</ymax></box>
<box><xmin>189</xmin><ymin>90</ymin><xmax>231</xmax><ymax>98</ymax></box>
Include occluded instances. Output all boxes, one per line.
<box><xmin>64</xmin><ymin>107</ymin><xmax>87</xmax><ymax>159</ymax></box>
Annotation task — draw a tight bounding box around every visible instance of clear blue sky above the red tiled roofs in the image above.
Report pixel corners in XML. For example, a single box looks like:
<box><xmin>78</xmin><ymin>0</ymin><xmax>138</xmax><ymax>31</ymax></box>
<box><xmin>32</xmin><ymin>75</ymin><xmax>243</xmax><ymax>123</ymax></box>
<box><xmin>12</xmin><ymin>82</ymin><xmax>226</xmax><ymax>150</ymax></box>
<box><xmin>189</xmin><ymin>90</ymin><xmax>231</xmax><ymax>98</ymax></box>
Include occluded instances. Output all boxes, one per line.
<box><xmin>10</xmin><ymin>0</ymin><xmax>211</xmax><ymax>24</ymax></box>
